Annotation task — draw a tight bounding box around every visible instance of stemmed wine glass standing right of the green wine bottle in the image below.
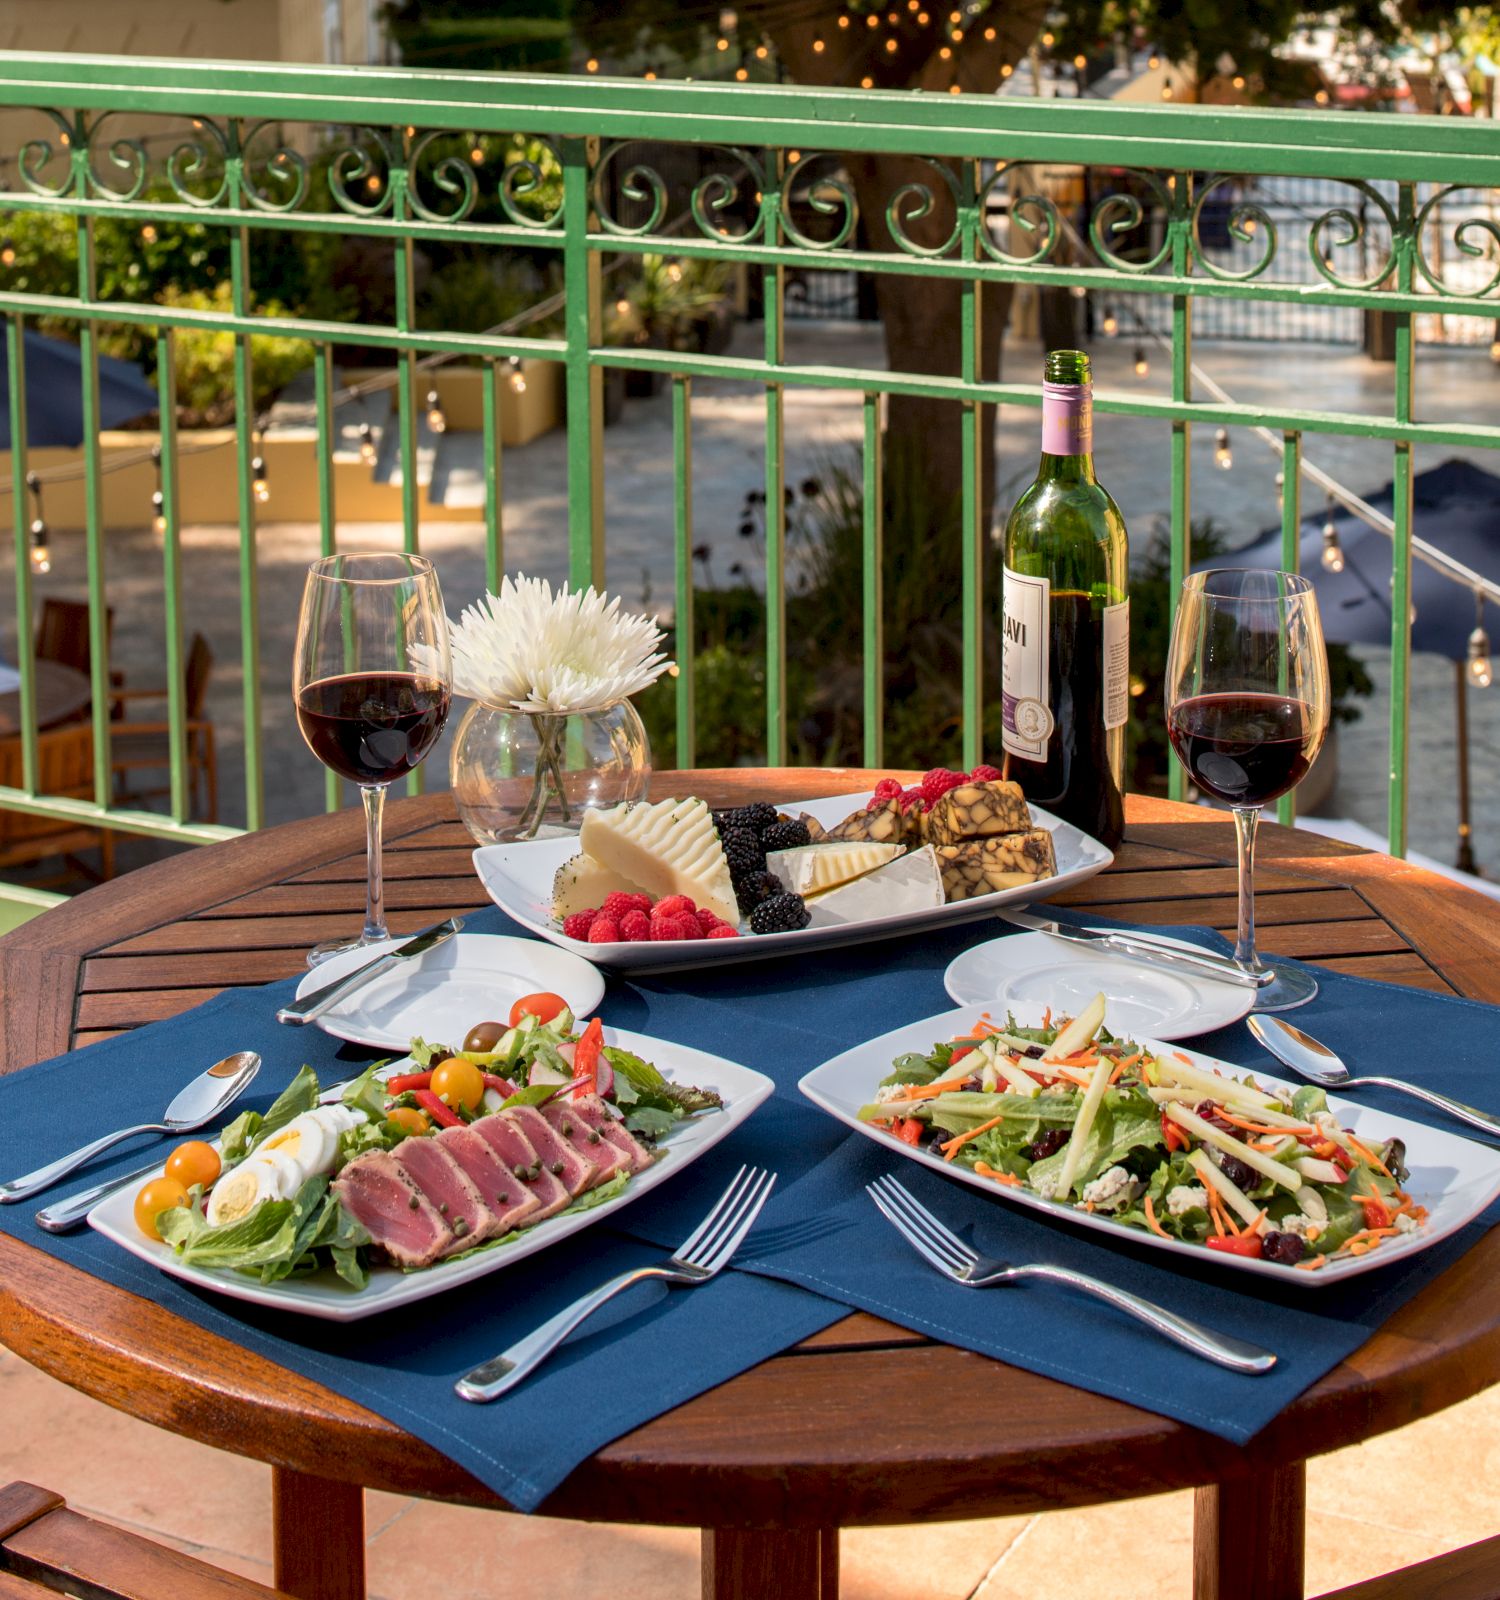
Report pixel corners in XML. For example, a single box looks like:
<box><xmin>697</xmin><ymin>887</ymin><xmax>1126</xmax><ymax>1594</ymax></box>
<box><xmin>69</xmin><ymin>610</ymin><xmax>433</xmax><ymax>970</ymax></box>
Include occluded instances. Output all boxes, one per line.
<box><xmin>1166</xmin><ymin>568</ymin><xmax>1329</xmax><ymax>1011</ymax></box>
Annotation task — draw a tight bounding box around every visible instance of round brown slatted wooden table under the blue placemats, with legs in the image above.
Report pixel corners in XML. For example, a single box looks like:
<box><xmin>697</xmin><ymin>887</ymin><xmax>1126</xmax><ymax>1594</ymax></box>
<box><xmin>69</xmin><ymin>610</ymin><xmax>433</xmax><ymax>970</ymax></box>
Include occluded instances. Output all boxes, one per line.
<box><xmin>0</xmin><ymin>770</ymin><xmax>1500</xmax><ymax>1600</ymax></box>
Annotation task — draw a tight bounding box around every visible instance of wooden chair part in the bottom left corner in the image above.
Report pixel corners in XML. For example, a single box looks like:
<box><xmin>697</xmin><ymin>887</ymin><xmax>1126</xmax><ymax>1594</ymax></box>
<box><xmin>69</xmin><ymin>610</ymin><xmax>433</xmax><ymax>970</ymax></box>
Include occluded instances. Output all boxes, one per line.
<box><xmin>0</xmin><ymin>1483</ymin><xmax>289</xmax><ymax>1600</ymax></box>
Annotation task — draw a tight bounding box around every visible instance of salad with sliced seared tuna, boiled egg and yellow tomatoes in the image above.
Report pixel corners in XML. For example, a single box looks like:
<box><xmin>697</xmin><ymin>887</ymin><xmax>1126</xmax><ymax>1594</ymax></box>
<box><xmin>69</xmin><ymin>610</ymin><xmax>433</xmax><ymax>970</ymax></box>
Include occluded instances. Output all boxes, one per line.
<box><xmin>134</xmin><ymin>995</ymin><xmax>723</xmax><ymax>1288</ymax></box>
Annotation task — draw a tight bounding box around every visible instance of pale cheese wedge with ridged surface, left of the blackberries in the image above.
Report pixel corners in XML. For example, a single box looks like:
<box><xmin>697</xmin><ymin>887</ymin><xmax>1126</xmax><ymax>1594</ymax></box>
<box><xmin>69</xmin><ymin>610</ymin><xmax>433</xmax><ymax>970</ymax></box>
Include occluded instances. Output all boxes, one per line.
<box><xmin>579</xmin><ymin>800</ymin><xmax>740</xmax><ymax>926</ymax></box>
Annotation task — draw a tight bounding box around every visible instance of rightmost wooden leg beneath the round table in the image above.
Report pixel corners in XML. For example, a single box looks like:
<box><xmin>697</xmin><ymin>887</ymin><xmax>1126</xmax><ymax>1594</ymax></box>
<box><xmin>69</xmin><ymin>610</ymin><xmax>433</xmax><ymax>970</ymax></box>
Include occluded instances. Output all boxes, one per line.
<box><xmin>1193</xmin><ymin>1461</ymin><xmax>1307</xmax><ymax>1600</ymax></box>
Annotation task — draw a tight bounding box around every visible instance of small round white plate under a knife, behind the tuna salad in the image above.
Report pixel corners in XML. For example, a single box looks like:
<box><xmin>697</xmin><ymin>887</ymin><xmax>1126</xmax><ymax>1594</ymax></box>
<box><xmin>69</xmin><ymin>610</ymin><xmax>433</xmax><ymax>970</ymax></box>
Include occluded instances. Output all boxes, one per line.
<box><xmin>289</xmin><ymin>933</ymin><xmax>604</xmax><ymax>1054</ymax></box>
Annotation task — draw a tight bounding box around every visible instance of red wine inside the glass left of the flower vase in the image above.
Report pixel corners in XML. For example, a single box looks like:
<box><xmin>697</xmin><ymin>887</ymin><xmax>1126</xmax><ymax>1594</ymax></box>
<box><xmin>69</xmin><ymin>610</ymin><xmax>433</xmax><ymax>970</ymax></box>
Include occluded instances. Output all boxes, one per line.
<box><xmin>297</xmin><ymin>672</ymin><xmax>449</xmax><ymax>784</ymax></box>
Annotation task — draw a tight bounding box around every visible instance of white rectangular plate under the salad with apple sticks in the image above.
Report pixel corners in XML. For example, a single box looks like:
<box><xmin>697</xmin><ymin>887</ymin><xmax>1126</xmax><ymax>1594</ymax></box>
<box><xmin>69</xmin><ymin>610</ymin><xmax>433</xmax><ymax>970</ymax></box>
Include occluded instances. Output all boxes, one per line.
<box><xmin>798</xmin><ymin>1006</ymin><xmax>1500</xmax><ymax>1288</ymax></box>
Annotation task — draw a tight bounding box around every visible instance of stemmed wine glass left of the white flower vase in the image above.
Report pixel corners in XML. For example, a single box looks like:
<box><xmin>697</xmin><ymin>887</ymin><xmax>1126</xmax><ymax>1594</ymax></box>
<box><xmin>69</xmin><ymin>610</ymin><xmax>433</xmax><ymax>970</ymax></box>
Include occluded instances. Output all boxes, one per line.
<box><xmin>293</xmin><ymin>555</ymin><xmax>453</xmax><ymax>966</ymax></box>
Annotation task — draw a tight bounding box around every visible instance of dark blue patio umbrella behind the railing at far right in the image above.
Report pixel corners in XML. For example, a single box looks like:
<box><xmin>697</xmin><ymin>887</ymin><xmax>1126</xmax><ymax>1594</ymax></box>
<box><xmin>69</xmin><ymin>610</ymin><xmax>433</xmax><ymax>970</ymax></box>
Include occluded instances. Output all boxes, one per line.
<box><xmin>1198</xmin><ymin>459</ymin><xmax>1500</xmax><ymax>661</ymax></box>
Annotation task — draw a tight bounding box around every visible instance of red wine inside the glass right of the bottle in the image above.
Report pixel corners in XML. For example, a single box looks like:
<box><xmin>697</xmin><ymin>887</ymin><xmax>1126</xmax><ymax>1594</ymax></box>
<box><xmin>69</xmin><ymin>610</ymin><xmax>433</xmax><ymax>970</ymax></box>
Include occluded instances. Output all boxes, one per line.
<box><xmin>1167</xmin><ymin>694</ymin><xmax>1321</xmax><ymax>806</ymax></box>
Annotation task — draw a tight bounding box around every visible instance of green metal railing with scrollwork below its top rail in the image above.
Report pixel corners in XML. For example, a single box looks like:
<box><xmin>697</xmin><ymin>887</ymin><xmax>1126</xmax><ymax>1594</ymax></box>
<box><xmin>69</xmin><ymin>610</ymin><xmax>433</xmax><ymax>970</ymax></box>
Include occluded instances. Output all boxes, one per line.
<box><xmin>0</xmin><ymin>54</ymin><xmax>1500</xmax><ymax>851</ymax></box>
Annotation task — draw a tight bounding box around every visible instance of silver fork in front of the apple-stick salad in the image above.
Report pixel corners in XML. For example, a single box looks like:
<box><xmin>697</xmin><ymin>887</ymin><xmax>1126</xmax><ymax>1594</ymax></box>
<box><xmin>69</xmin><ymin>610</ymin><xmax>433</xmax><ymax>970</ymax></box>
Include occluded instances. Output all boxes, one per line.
<box><xmin>865</xmin><ymin>1176</ymin><xmax>1276</xmax><ymax>1373</ymax></box>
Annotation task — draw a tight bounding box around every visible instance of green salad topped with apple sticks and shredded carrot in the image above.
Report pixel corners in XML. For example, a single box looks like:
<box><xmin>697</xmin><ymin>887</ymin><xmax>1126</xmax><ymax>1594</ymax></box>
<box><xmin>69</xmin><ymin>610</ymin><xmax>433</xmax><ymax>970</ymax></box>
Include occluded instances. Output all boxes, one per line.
<box><xmin>860</xmin><ymin>995</ymin><xmax>1426</xmax><ymax>1272</ymax></box>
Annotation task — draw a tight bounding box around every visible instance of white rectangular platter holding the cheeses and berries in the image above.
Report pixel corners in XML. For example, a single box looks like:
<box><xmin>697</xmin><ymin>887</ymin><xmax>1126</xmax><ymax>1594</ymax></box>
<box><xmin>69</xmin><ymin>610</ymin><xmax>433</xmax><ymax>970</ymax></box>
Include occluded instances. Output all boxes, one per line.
<box><xmin>473</xmin><ymin>790</ymin><xmax>1115</xmax><ymax>973</ymax></box>
